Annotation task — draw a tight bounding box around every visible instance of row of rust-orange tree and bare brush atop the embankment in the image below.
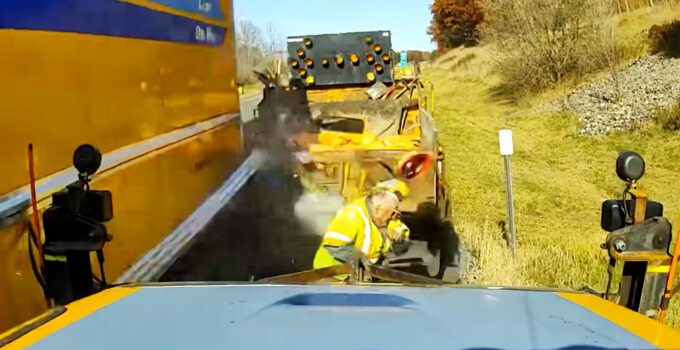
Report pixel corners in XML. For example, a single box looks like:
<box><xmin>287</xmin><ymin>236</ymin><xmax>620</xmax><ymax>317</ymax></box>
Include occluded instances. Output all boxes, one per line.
<box><xmin>427</xmin><ymin>0</ymin><xmax>679</xmax><ymax>94</ymax></box>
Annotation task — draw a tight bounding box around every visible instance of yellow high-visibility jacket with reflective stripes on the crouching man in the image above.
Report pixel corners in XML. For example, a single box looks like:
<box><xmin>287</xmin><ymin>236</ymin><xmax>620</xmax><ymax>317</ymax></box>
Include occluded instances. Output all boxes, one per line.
<box><xmin>314</xmin><ymin>198</ymin><xmax>390</xmax><ymax>269</ymax></box>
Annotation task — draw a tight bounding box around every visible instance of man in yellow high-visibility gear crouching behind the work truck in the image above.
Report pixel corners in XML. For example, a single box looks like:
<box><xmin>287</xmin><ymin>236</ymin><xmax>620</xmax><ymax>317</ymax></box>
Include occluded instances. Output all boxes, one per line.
<box><xmin>314</xmin><ymin>179</ymin><xmax>409</xmax><ymax>269</ymax></box>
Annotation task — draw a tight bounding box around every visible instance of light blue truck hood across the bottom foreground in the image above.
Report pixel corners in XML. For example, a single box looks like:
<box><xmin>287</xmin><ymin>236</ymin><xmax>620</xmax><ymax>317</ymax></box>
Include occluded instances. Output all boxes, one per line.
<box><xmin>6</xmin><ymin>284</ymin><xmax>680</xmax><ymax>350</ymax></box>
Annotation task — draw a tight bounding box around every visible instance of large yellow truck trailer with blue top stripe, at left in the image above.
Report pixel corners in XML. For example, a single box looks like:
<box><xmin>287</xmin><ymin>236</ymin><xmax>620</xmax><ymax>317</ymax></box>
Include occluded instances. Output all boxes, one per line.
<box><xmin>0</xmin><ymin>0</ymin><xmax>243</xmax><ymax>330</ymax></box>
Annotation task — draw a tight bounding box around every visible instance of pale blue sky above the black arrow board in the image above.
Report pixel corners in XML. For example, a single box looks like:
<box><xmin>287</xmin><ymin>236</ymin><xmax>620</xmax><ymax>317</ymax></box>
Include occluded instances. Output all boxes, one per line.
<box><xmin>233</xmin><ymin>0</ymin><xmax>435</xmax><ymax>51</ymax></box>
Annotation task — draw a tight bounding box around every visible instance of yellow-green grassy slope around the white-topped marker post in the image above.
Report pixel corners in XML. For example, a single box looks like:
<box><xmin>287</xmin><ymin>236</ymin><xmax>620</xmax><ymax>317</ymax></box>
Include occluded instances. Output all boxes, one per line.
<box><xmin>423</xmin><ymin>4</ymin><xmax>680</xmax><ymax>327</ymax></box>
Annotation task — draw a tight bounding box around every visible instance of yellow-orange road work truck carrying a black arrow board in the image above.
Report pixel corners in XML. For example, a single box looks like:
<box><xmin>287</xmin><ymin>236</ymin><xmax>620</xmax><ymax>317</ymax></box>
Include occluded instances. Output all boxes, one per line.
<box><xmin>261</xmin><ymin>31</ymin><xmax>460</xmax><ymax>281</ymax></box>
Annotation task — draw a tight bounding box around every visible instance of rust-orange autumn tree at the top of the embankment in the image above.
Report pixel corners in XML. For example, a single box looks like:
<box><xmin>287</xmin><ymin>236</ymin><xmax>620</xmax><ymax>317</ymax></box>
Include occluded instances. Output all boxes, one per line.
<box><xmin>427</xmin><ymin>0</ymin><xmax>484</xmax><ymax>52</ymax></box>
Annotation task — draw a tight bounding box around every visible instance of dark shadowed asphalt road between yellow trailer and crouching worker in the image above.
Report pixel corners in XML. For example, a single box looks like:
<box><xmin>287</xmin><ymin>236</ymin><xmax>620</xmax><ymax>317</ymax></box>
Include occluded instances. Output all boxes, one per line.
<box><xmin>161</xmin><ymin>94</ymin><xmax>321</xmax><ymax>282</ymax></box>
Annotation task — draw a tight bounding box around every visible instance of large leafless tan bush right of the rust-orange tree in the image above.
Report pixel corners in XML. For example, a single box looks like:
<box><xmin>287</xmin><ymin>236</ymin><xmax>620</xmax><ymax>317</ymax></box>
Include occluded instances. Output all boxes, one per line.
<box><xmin>485</xmin><ymin>0</ymin><xmax>603</xmax><ymax>90</ymax></box>
